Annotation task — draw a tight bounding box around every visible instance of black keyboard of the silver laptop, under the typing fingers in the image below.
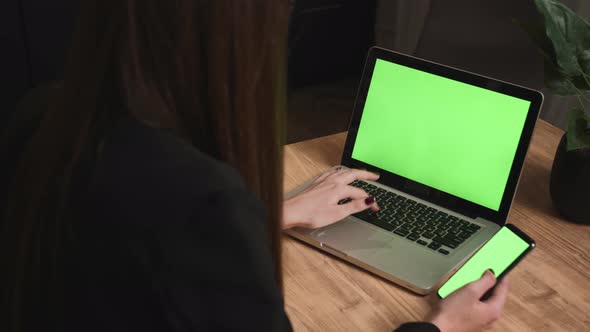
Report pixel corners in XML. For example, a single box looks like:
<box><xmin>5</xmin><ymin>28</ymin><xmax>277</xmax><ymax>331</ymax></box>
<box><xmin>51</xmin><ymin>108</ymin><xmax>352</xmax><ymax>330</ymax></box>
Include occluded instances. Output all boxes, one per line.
<box><xmin>338</xmin><ymin>180</ymin><xmax>481</xmax><ymax>255</ymax></box>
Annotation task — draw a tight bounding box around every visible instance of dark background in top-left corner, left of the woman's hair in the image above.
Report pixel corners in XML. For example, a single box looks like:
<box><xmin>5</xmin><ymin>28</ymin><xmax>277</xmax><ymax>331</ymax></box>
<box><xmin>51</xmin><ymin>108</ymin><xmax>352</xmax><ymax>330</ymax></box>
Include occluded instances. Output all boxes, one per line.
<box><xmin>0</xmin><ymin>0</ymin><xmax>76</xmax><ymax>128</ymax></box>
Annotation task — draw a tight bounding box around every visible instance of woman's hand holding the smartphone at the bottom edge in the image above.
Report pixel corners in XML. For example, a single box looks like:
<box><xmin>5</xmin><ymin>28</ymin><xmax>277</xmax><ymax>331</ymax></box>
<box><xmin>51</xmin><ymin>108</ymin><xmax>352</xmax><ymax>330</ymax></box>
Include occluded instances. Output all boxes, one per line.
<box><xmin>428</xmin><ymin>271</ymin><xmax>508</xmax><ymax>332</ymax></box>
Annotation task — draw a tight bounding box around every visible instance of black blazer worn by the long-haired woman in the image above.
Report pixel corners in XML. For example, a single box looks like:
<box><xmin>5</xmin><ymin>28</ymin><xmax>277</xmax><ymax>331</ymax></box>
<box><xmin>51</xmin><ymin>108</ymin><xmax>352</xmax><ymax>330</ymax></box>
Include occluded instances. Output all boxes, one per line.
<box><xmin>2</xmin><ymin>91</ymin><xmax>438</xmax><ymax>332</ymax></box>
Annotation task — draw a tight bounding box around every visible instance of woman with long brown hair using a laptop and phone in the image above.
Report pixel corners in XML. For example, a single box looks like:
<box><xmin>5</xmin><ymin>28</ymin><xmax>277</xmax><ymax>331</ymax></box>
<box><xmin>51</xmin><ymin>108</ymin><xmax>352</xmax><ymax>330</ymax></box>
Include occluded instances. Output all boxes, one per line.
<box><xmin>0</xmin><ymin>0</ymin><xmax>507</xmax><ymax>331</ymax></box>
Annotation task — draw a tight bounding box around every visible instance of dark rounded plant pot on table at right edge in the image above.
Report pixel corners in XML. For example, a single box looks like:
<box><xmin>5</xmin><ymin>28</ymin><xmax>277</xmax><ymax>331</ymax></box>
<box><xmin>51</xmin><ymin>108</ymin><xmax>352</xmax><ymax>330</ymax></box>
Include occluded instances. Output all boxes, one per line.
<box><xmin>549</xmin><ymin>134</ymin><xmax>590</xmax><ymax>224</ymax></box>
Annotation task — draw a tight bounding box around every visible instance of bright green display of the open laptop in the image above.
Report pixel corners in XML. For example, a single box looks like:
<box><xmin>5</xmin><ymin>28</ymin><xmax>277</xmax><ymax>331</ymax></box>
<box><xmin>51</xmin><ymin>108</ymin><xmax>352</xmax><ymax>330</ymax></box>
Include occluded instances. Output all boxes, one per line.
<box><xmin>352</xmin><ymin>59</ymin><xmax>531</xmax><ymax>211</ymax></box>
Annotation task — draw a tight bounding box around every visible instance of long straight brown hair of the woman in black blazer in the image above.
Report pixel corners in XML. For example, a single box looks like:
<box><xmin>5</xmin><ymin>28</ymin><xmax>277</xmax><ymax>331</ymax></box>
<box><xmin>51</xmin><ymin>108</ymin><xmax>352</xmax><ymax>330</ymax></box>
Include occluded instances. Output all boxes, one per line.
<box><xmin>0</xmin><ymin>0</ymin><xmax>288</xmax><ymax>331</ymax></box>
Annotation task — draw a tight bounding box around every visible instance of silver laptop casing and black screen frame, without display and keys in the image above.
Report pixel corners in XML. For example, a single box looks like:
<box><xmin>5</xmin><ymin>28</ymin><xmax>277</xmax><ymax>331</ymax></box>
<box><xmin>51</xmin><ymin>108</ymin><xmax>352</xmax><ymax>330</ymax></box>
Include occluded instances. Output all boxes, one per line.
<box><xmin>286</xmin><ymin>48</ymin><xmax>543</xmax><ymax>294</ymax></box>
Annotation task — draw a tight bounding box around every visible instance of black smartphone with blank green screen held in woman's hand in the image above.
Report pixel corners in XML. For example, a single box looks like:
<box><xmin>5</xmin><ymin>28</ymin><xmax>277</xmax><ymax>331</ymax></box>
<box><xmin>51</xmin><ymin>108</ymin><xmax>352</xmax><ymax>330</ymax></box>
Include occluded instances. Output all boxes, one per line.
<box><xmin>438</xmin><ymin>224</ymin><xmax>535</xmax><ymax>300</ymax></box>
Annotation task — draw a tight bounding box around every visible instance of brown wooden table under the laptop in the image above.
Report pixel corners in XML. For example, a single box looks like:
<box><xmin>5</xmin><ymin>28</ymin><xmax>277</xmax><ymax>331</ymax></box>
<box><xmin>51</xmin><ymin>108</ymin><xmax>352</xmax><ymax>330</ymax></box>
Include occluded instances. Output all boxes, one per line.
<box><xmin>283</xmin><ymin>120</ymin><xmax>590</xmax><ymax>331</ymax></box>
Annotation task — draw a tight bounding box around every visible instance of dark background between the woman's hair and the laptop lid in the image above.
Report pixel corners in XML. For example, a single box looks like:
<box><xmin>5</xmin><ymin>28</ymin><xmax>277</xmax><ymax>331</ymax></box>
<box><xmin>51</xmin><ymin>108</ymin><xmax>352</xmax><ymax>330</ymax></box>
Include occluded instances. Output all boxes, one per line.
<box><xmin>287</xmin><ymin>0</ymin><xmax>376</xmax><ymax>142</ymax></box>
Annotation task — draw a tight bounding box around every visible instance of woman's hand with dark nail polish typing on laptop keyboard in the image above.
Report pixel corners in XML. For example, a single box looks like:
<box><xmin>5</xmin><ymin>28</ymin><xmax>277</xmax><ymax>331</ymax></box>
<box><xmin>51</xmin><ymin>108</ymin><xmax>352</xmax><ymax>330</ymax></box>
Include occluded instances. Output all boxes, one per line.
<box><xmin>283</xmin><ymin>169</ymin><xmax>379</xmax><ymax>229</ymax></box>
